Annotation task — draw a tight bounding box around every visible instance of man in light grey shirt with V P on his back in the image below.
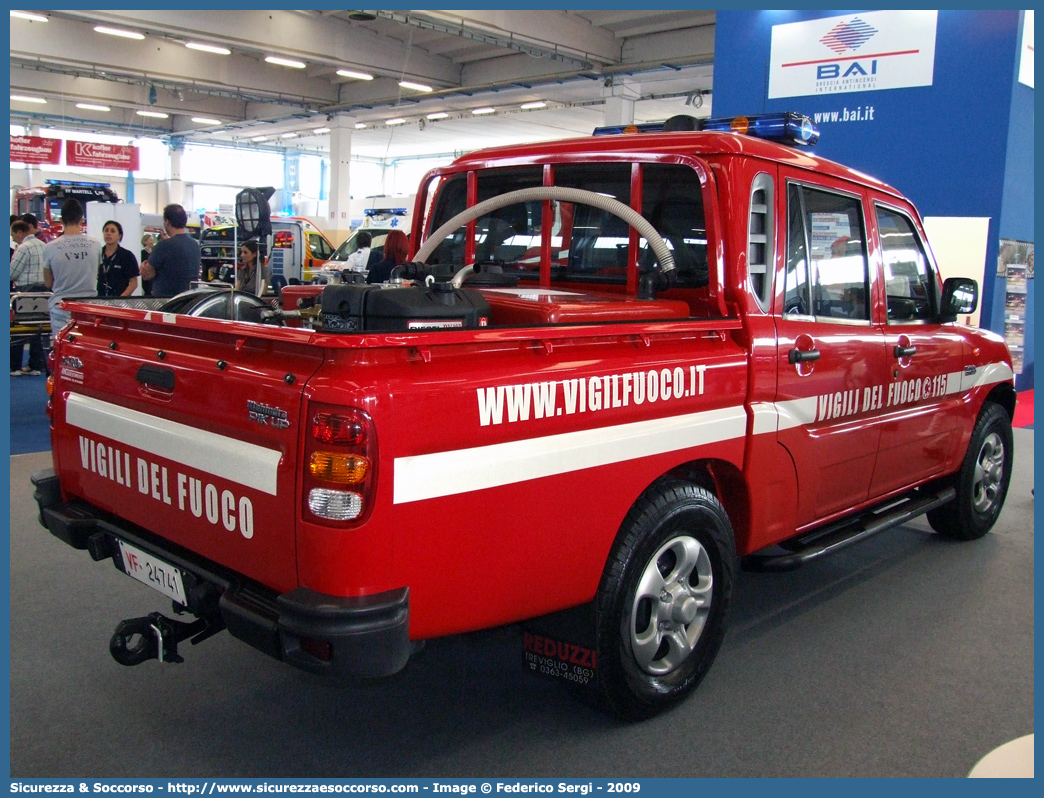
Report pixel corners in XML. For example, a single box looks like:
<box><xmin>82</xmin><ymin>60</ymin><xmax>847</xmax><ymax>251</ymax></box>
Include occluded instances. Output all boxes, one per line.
<box><xmin>44</xmin><ymin>200</ymin><xmax>101</xmax><ymax>338</ymax></box>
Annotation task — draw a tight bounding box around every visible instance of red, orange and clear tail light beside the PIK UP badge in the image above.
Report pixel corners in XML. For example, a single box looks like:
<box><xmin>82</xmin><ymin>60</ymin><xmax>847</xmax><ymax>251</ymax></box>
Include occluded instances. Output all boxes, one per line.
<box><xmin>304</xmin><ymin>403</ymin><xmax>377</xmax><ymax>523</ymax></box>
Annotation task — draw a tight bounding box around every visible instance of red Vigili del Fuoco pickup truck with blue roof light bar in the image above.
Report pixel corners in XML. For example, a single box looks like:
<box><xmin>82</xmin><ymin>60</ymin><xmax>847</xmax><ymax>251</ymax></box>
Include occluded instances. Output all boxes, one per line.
<box><xmin>33</xmin><ymin>114</ymin><xmax>1015</xmax><ymax>719</ymax></box>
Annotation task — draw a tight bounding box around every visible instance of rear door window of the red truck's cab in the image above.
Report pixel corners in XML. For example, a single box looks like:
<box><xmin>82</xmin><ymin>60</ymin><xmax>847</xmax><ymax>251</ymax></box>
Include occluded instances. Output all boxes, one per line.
<box><xmin>783</xmin><ymin>184</ymin><xmax>870</xmax><ymax>322</ymax></box>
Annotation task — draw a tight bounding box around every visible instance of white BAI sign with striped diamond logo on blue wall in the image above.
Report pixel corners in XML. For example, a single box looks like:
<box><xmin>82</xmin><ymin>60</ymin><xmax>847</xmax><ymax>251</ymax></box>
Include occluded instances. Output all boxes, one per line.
<box><xmin>768</xmin><ymin>11</ymin><xmax>939</xmax><ymax>99</ymax></box>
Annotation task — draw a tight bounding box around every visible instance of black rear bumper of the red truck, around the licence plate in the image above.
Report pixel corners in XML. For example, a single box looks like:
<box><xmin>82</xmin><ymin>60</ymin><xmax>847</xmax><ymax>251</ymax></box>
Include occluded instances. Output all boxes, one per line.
<box><xmin>32</xmin><ymin>469</ymin><xmax>414</xmax><ymax>679</ymax></box>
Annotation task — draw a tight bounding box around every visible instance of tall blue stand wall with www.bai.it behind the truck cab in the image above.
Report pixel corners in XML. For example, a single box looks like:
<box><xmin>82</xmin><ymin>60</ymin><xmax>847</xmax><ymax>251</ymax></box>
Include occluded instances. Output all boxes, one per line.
<box><xmin>713</xmin><ymin>10</ymin><xmax>1034</xmax><ymax>388</ymax></box>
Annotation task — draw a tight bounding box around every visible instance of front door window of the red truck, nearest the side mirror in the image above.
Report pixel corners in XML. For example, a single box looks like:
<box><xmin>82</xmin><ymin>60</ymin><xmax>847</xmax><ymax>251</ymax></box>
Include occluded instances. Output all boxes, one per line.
<box><xmin>877</xmin><ymin>206</ymin><xmax>935</xmax><ymax>324</ymax></box>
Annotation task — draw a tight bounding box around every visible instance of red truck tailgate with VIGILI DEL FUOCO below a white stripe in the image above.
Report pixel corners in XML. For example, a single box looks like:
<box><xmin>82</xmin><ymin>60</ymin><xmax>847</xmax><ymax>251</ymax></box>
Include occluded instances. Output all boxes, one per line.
<box><xmin>52</xmin><ymin>310</ymin><xmax>322</xmax><ymax>591</ymax></box>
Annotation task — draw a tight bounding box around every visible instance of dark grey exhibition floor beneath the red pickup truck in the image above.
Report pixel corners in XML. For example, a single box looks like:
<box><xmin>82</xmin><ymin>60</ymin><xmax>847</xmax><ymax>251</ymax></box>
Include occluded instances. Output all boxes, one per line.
<box><xmin>10</xmin><ymin>429</ymin><xmax>1034</xmax><ymax>777</ymax></box>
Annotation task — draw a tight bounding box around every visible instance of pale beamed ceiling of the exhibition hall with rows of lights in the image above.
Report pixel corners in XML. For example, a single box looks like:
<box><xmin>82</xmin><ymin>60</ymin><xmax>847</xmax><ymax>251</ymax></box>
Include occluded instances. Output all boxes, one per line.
<box><xmin>10</xmin><ymin>9</ymin><xmax>715</xmax><ymax>160</ymax></box>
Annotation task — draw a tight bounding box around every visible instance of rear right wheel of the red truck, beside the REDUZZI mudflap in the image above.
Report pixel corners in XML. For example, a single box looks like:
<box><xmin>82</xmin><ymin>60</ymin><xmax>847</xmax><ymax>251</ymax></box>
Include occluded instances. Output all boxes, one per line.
<box><xmin>596</xmin><ymin>479</ymin><xmax>736</xmax><ymax>721</ymax></box>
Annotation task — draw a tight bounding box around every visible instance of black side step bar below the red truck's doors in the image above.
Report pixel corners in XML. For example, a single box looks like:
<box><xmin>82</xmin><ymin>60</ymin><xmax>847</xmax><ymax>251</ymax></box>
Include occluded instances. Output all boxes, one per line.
<box><xmin>740</xmin><ymin>487</ymin><xmax>956</xmax><ymax>573</ymax></box>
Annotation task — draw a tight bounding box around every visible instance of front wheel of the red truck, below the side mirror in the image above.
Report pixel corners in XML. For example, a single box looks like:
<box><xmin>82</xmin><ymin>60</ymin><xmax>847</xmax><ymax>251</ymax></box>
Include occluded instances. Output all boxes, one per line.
<box><xmin>928</xmin><ymin>402</ymin><xmax>1014</xmax><ymax>540</ymax></box>
